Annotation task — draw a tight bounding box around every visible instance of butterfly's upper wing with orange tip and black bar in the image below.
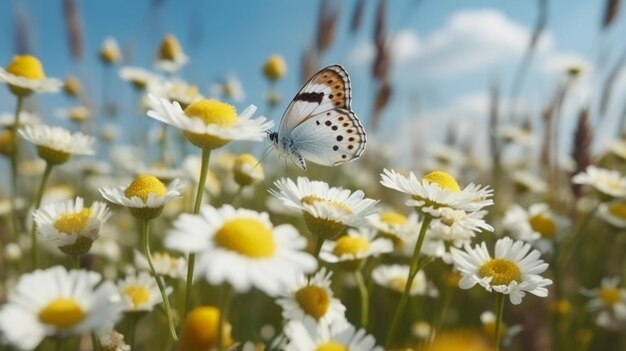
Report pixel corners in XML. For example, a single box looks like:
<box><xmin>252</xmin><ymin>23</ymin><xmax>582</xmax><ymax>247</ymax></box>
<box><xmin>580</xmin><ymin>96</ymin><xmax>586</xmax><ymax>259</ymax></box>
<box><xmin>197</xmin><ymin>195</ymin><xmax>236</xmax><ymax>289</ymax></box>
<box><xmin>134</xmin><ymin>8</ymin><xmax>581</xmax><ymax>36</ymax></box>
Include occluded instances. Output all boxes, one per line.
<box><xmin>278</xmin><ymin>65</ymin><xmax>352</xmax><ymax>136</ymax></box>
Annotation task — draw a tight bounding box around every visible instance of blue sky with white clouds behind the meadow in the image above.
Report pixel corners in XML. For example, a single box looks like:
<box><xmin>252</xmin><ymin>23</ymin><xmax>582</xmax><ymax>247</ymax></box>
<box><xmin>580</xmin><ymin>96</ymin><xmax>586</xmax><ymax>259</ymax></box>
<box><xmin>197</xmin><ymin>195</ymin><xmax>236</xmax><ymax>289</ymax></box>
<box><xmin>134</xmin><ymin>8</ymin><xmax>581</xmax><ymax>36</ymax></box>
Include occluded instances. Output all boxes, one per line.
<box><xmin>0</xmin><ymin>0</ymin><xmax>626</xmax><ymax>164</ymax></box>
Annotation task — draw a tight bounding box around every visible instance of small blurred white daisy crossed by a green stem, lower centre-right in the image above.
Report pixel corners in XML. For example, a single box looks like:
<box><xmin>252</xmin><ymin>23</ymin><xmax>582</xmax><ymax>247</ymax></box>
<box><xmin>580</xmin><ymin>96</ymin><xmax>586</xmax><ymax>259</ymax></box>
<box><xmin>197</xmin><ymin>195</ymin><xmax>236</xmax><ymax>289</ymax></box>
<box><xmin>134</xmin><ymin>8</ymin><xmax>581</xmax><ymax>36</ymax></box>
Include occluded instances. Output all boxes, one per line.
<box><xmin>372</xmin><ymin>264</ymin><xmax>439</xmax><ymax>297</ymax></box>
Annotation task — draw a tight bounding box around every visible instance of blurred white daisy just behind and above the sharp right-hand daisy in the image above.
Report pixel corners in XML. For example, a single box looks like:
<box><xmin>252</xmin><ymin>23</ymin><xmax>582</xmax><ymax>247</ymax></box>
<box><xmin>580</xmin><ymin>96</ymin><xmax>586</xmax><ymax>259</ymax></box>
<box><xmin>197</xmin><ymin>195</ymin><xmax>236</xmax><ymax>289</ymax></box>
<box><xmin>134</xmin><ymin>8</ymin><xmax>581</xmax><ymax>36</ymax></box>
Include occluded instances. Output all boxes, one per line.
<box><xmin>502</xmin><ymin>203</ymin><xmax>569</xmax><ymax>252</ymax></box>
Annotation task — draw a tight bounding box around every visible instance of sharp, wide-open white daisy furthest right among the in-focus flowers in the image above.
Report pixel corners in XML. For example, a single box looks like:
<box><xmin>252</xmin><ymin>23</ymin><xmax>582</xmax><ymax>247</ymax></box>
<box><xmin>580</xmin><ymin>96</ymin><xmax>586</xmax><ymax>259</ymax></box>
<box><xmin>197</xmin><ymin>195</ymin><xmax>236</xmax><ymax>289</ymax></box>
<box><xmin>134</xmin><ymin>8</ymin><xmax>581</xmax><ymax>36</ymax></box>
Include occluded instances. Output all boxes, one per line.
<box><xmin>451</xmin><ymin>237</ymin><xmax>552</xmax><ymax>305</ymax></box>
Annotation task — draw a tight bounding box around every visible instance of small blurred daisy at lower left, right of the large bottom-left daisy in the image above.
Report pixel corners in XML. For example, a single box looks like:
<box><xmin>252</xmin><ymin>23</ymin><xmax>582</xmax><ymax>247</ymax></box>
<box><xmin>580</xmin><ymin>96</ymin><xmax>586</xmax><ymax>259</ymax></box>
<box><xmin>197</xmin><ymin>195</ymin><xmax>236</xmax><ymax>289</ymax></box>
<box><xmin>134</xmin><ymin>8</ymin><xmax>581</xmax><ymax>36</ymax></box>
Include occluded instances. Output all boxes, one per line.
<box><xmin>117</xmin><ymin>272</ymin><xmax>172</xmax><ymax>313</ymax></box>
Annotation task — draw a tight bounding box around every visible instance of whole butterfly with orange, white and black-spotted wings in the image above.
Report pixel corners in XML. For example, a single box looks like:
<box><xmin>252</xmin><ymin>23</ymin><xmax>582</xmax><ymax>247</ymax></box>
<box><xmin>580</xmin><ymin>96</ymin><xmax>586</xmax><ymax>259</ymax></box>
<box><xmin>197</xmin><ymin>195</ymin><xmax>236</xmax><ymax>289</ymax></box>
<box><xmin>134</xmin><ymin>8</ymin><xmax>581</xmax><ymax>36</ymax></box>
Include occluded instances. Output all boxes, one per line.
<box><xmin>268</xmin><ymin>65</ymin><xmax>366</xmax><ymax>170</ymax></box>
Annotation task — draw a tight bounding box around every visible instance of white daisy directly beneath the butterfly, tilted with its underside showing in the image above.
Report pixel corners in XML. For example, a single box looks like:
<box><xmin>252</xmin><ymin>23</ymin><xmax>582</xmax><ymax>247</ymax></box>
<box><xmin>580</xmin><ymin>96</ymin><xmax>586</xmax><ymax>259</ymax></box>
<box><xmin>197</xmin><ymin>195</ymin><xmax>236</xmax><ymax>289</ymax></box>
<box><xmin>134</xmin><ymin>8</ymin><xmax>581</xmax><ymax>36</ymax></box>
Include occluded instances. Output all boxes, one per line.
<box><xmin>269</xmin><ymin>177</ymin><xmax>378</xmax><ymax>239</ymax></box>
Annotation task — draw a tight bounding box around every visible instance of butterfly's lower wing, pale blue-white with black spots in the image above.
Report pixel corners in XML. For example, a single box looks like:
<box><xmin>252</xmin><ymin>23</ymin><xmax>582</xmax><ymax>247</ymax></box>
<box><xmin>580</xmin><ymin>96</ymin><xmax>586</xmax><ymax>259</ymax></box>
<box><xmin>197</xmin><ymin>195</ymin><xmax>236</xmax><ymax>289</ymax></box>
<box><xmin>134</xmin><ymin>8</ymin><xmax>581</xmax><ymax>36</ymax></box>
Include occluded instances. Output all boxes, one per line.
<box><xmin>292</xmin><ymin>108</ymin><xmax>366</xmax><ymax>168</ymax></box>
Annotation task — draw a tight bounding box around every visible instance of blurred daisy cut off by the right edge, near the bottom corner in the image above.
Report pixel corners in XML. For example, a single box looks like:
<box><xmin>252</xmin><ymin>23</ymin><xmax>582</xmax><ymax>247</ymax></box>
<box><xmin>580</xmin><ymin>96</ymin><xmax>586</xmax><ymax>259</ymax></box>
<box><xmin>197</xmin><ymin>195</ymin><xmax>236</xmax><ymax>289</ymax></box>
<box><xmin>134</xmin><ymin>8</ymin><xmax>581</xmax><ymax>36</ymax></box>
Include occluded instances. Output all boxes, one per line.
<box><xmin>582</xmin><ymin>277</ymin><xmax>626</xmax><ymax>330</ymax></box>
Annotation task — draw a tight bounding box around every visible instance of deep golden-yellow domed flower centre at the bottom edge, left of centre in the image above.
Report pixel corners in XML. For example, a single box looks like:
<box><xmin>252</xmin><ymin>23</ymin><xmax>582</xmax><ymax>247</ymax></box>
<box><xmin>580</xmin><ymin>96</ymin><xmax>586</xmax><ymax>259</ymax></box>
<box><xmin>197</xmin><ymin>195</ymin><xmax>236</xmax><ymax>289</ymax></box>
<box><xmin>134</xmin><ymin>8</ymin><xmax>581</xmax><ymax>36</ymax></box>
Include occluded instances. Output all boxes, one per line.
<box><xmin>178</xmin><ymin>306</ymin><xmax>232</xmax><ymax>351</ymax></box>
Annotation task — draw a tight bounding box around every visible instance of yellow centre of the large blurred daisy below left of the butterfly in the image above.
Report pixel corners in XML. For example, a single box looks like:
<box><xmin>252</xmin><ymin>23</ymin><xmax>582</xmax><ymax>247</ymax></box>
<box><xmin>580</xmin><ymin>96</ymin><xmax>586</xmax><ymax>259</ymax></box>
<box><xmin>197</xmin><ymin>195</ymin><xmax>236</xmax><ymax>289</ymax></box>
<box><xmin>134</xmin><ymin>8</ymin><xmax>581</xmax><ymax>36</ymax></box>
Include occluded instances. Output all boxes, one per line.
<box><xmin>215</xmin><ymin>218</ymin><xmax>276</xmax><ymax>258</ymax></box>
